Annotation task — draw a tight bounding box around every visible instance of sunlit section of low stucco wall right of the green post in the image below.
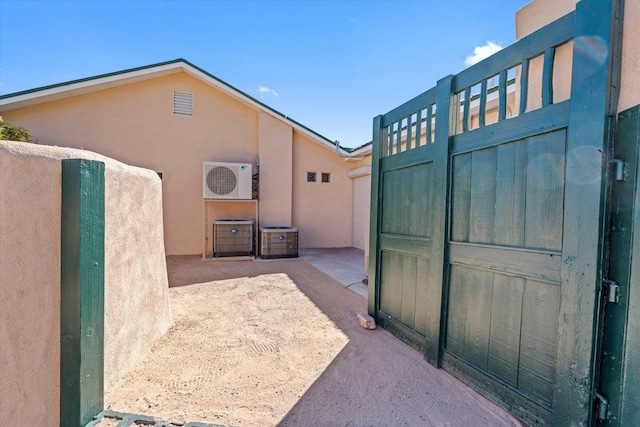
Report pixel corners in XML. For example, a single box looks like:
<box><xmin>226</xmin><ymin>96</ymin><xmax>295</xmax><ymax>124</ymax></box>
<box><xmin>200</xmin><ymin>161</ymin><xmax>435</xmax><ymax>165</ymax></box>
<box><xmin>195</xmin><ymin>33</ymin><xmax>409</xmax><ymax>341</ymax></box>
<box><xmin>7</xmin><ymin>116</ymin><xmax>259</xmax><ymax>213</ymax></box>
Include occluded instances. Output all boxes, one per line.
<box><xmin>102</xmin><ymin>154</ymin><xmax>171</xmax><ymax>389</ymax></box>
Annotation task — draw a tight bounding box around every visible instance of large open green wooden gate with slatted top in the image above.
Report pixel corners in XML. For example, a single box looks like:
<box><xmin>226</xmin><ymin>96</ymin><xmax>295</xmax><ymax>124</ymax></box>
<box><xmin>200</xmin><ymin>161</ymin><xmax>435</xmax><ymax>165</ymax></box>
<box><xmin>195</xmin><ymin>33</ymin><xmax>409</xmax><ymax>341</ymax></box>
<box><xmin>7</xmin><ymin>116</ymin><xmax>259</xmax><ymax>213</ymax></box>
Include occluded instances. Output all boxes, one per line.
<box><xmin>369</xmin><ymin>0</ymin><xmax>622</xmax><ymax>425</ymax></box>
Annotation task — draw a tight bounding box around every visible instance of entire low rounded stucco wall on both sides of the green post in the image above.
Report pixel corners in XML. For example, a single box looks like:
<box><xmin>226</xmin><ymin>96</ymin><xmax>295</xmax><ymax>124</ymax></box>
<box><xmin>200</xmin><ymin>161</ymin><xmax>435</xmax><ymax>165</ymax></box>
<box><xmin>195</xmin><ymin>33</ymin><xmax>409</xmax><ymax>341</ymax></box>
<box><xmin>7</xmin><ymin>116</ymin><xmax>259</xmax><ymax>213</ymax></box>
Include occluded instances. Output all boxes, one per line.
<box><xmin>0</xmin><ymin>141</ymin><xmax>171</xmax><ymax>426</ymax></box>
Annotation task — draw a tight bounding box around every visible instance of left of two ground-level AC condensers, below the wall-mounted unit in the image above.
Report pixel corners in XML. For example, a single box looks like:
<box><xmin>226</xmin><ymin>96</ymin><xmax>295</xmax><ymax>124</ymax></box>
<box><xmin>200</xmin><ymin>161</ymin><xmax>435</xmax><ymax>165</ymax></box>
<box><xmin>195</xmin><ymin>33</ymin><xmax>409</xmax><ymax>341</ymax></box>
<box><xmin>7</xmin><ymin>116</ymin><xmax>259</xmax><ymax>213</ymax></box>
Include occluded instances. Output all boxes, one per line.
<box><xmin>213</xmin><ymin>220</ymin><xmax>254</xmax><ymax>258</ymax></box>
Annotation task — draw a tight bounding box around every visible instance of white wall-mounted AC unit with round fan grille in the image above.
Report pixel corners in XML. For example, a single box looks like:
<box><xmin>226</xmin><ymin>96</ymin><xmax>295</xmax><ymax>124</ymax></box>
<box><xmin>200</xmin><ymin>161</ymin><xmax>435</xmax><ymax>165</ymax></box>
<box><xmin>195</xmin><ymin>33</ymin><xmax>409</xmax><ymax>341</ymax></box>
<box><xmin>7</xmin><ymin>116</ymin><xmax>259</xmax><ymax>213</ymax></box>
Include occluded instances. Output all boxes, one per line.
<box><xmin>202</xmin><ymin>162</ymin><xmax>252</xmax><ymax>200</ymax></box>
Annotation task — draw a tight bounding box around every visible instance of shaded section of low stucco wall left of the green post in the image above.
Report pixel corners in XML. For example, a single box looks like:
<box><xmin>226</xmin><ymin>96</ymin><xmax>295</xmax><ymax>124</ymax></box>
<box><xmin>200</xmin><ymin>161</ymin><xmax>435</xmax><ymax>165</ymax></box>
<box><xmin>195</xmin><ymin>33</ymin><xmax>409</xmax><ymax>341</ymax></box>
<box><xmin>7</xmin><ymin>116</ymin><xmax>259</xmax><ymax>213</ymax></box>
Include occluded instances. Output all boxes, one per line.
<box><xmin>0</xmin><ymin>142</ymin><xmax>61</xmax><ymax>426</ymax></box>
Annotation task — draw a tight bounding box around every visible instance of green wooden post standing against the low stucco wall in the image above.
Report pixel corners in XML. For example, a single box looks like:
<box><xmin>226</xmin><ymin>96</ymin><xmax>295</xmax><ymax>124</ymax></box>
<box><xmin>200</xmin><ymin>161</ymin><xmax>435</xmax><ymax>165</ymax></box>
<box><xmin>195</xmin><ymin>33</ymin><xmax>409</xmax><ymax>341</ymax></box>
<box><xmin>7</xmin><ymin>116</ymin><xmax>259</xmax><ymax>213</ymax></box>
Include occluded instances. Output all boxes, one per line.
<box><xmin>60</xmin><ymin>159</ymin><xmax>104</xmax><ymax>427</ymax></box>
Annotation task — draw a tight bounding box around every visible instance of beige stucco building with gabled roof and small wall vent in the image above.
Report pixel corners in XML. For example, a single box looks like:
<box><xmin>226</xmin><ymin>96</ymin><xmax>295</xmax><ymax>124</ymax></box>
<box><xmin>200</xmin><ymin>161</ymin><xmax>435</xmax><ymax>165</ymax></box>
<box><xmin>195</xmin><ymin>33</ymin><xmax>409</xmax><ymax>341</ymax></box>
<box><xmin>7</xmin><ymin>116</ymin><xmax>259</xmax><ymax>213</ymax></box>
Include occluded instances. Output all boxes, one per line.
<box><xmin>0</xmin><ymin>59</ymin><xmax>370</xmax><ymax>255</ymax></box>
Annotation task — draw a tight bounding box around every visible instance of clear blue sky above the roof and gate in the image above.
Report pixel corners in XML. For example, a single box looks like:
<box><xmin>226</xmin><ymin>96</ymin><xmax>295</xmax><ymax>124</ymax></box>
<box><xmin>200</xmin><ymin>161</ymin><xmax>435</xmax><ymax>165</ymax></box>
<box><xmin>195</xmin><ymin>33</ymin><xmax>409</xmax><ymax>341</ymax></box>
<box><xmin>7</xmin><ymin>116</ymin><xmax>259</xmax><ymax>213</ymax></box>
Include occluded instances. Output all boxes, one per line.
<box><xmin>0</xmin><ymin>0</ymin><xmax>530</xmax><ymax>147</ymax></box>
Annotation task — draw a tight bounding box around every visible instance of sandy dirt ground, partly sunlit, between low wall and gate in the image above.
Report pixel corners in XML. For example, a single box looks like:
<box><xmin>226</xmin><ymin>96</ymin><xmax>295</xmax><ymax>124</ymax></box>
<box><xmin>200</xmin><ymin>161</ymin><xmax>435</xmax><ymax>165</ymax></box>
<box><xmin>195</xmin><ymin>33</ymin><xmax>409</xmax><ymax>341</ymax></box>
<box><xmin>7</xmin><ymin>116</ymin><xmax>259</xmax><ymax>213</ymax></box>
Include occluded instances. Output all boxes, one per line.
<box><xmin>105</xmin><ymin>257</ymin><xmax>521</xmax><ymax>427</ymax></box>
